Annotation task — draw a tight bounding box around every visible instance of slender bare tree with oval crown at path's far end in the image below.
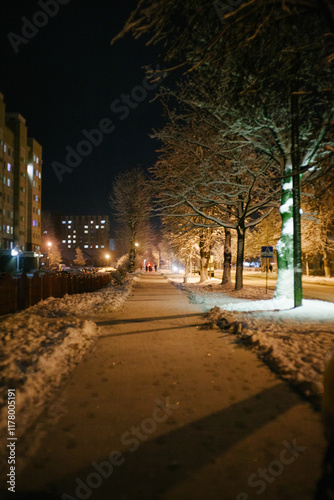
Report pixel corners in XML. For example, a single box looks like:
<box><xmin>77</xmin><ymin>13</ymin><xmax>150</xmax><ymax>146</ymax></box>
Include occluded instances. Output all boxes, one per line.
<box><xmin>109</xmin><ymin>166</ymin><xmax>151</xmax><ymax>272</ymax></box>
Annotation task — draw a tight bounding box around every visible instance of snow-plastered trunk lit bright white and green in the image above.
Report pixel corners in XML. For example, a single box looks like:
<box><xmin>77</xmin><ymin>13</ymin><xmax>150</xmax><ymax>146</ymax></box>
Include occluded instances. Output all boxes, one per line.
<box><xmin>274</xmin><ymin>164</ymin><xmax>294</xmax><ymax>300</ymax></box>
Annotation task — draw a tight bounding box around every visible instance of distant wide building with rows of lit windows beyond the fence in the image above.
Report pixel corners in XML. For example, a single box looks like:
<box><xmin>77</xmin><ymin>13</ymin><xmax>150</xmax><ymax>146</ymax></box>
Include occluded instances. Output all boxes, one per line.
<box><xmin>55</xmin><ymin>215</ymin><xmax>111</xmax><ymax>266</ymax></box>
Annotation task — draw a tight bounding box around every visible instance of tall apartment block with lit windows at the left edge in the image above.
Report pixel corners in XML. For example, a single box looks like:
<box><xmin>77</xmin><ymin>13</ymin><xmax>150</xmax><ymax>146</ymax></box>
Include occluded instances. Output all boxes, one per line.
<box><xmin>0</xmin><ymin>93</ymin><xmax>42</xmax><ymax>271</ymax></box>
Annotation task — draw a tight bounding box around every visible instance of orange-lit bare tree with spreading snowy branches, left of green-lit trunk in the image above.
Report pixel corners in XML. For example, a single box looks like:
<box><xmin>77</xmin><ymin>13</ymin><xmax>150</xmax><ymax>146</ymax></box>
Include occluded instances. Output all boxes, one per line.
<box><xmin>151</xmin><ymin>107</ymin><xmax>280</xmax><ymax>289</ymax></box>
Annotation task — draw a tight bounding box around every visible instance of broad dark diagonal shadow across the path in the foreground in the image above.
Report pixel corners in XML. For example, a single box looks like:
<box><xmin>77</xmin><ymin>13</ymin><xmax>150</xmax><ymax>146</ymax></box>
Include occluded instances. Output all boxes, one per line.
<box><xmin>18</xmin><ymin>383</ymin><xmax>300</xmax><ymax>500</ymax></box>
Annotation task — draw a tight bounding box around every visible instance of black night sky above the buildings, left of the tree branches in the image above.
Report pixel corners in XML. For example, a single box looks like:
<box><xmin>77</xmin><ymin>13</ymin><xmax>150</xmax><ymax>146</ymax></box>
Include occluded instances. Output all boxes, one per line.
<box><xmin>0</xmin><ymin>0</ymin><xmax>163</xmax><ymax>215</ymax></box>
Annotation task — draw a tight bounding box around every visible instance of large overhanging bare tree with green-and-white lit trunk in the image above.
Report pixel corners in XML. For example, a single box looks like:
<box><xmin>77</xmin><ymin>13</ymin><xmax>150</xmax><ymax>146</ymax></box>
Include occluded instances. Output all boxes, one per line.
<box><xmin>113</xmin><ymin>0</ymin><xmax>334</xmax><ymax>297</ymax></box>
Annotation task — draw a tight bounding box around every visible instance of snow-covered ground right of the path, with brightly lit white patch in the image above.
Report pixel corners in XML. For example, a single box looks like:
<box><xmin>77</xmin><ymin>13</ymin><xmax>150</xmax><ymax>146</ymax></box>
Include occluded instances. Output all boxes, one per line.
<box><xmin>170</xmin><ymin>276</ymin><xmax>334</xmax><ymax>407</ymax></box>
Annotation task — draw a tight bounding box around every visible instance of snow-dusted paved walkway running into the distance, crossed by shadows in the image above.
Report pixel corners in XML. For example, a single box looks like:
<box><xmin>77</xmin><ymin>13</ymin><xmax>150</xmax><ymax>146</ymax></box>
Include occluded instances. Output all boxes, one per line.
<box><xmin>15</xmin><ymin>273</ymin><xmax>325</xmax><ymax>500</ymax></box>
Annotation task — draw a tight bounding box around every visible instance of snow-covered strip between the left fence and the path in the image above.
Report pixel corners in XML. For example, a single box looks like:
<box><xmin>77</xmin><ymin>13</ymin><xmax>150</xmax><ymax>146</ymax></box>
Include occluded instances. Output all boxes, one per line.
<box><xmin>0</xmin><ymin>280</ymin><xmax>133</xmax><ymax>442</ymax></box>
